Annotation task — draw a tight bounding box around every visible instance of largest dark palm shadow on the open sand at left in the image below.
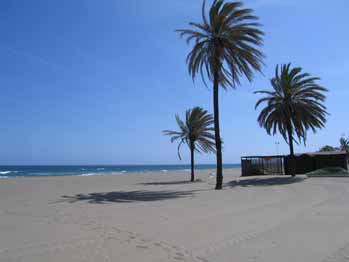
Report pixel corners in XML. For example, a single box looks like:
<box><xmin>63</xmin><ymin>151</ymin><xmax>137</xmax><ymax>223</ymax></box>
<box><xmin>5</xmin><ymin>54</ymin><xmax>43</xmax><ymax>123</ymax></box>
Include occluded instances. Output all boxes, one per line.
<box><xmin>58</xmin><ymin>191</ymin><xmax>195</xmax><ymax>204</ymax></box>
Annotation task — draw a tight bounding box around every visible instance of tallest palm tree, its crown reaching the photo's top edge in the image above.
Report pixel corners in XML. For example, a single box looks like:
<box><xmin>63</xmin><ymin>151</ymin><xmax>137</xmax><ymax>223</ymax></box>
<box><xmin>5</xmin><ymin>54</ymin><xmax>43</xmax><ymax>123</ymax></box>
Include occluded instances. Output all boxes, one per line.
<box><xmin>177</xmin><ymin>0</ymin><xmax>263</xmax><ymax>189</ymax></box>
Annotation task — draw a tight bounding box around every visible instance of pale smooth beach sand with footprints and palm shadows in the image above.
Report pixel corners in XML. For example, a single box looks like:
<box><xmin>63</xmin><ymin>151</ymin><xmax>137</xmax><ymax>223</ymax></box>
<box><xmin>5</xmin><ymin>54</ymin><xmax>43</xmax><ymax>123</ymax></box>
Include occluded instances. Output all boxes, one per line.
<box><xmin>0</xmin><ymin>169</ymin><xmax>349</xmax><ymax>262</ymax></box>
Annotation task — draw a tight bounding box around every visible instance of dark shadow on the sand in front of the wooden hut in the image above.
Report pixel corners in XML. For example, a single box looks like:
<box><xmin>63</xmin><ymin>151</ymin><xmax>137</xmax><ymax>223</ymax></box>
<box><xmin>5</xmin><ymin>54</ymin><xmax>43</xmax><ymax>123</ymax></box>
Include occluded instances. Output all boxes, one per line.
<box><xmin>227</xmin><ymin>176</ymin><xmax>306</xmax><ymax>187</ymax></box>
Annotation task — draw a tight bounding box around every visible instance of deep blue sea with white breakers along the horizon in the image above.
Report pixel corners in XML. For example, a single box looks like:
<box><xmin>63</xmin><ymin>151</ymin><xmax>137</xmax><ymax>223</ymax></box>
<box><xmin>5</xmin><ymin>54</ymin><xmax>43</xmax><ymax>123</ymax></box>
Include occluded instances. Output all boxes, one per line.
<box><xmin>0</xmin><ymin>164</ymin><xmax>240</xmax><ymax>178</ymax></box>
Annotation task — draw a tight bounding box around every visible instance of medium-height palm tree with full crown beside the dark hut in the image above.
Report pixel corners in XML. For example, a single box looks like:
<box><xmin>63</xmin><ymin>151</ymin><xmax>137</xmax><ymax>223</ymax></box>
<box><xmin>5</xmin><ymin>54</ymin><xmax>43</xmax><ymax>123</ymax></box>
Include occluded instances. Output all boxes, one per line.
<box><xmin>255</xmin><ymin>64</ymin><xmax>328</xmax><ymax>175</ymax></box>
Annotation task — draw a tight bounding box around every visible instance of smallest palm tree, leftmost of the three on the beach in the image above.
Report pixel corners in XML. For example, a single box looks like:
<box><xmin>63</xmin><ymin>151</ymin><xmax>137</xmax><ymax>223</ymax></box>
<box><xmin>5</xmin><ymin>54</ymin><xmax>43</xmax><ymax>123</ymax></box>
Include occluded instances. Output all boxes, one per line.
<box><xmin>163</xmin><ymin>107</ymin><xmax>215</xmax><ymax>182</ymax></box>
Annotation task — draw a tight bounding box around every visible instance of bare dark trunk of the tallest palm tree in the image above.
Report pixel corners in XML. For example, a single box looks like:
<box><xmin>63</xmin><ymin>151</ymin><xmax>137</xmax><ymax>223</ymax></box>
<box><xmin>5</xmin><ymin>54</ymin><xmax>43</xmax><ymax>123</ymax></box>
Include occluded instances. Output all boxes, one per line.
<box><xmin>213</xmin><ymin>72</ymin><xmax>223</xmax><ymax>189</ymax></box>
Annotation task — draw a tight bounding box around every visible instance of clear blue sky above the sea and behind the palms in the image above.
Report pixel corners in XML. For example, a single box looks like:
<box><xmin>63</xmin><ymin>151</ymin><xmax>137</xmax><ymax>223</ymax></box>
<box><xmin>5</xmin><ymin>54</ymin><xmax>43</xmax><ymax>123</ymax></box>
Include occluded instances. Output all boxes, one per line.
<box><xmin>0</xmin><ymin>0</ymin><xmax>349</xmax><ymax>164</ymax></box>
